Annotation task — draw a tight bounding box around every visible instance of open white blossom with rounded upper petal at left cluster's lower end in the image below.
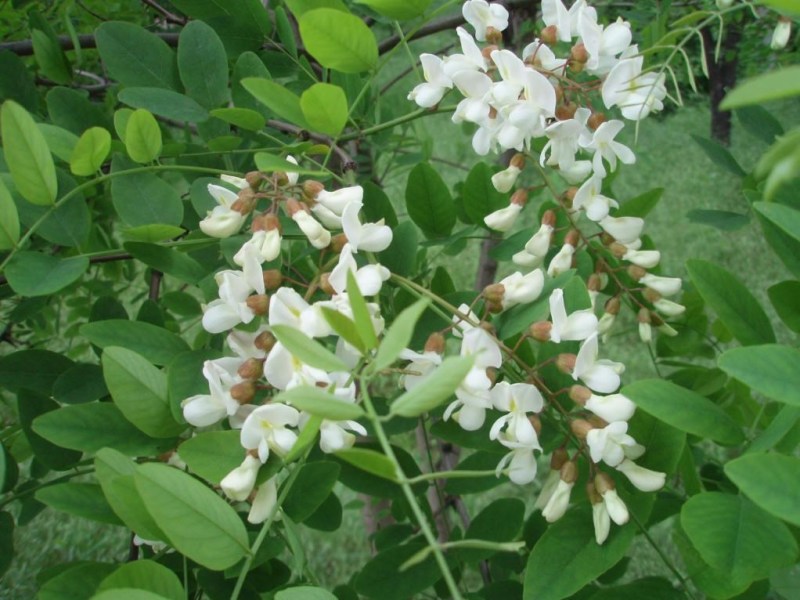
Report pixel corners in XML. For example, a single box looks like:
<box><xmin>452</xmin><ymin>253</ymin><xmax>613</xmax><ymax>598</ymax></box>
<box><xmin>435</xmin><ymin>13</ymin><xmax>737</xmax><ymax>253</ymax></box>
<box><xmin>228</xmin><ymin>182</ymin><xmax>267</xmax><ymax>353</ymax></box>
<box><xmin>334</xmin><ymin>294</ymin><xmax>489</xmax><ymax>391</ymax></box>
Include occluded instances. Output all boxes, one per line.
<box><xmin>240</xmin><ymin>402</ymin><xmax>300</xmax><ymax>463</ymax></box>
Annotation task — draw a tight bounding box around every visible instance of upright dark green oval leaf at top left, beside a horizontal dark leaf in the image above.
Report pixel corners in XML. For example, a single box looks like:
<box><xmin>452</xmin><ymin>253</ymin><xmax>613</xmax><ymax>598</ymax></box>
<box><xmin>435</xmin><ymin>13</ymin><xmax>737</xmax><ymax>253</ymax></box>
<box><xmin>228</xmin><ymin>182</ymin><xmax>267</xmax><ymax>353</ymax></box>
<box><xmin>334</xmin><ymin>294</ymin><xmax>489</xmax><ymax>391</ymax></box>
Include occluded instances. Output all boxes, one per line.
<box><xmin>178</xmin><ymin>21</ymin><xmax>230</xmax><ymax>108</ymax></box>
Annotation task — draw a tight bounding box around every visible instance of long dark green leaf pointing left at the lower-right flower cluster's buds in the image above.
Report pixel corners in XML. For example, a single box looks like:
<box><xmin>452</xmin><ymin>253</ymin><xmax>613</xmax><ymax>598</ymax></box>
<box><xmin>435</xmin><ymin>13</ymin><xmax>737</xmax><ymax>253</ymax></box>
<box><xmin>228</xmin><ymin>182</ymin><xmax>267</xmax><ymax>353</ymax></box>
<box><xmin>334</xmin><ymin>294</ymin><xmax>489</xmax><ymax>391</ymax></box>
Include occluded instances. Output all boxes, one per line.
<box><xmin>622</xmin><ymin>379</ymin><xmax>744</xmax><ymax>445</ymax></box>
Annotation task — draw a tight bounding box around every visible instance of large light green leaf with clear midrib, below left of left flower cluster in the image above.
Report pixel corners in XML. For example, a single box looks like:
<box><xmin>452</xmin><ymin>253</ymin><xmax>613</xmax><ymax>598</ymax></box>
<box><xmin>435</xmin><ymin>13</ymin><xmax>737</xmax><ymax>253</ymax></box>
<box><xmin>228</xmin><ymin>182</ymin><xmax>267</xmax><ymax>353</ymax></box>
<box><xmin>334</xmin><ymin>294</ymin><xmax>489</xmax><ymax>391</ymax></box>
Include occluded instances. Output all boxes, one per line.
<box><xmin>134</xmin><ymin>463</ymin><xmax>250</xmax><ymax>571</ymax></box>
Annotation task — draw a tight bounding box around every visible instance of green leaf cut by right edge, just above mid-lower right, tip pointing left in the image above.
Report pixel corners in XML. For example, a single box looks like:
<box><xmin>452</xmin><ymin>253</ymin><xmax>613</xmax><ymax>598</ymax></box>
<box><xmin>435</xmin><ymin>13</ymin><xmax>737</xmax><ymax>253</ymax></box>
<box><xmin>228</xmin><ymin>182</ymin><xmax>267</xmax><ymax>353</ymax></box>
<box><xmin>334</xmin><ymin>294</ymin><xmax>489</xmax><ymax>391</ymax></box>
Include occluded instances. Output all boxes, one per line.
<box><xmin>719</xmin><ymin>344</ymin><xmax>800</xmax><ymax>406</ymax></box>
